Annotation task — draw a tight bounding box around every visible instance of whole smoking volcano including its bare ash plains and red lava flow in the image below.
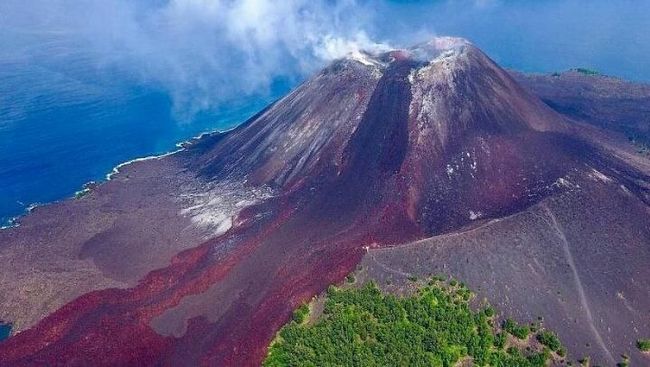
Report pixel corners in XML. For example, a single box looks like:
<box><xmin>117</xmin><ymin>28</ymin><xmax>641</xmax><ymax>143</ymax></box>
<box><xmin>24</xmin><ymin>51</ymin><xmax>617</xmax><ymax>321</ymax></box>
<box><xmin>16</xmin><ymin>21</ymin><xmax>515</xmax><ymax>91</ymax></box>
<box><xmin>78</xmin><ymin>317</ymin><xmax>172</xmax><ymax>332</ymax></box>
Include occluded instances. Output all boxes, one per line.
<box><xmin>0</xmin><ymin>37</ymin><xmax>650</xmax><ymax>366</ymax></box>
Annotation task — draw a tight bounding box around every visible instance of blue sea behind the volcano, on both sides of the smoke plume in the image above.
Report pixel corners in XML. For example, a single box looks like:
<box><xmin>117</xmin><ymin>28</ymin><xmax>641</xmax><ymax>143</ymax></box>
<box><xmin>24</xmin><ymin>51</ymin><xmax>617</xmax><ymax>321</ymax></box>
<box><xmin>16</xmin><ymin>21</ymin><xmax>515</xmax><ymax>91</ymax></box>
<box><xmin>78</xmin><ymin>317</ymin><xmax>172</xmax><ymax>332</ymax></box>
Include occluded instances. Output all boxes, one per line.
<box><xmin>0</xmin><ymin>0</ymin><xmax>650</xmax><ymax>226</ymax></box>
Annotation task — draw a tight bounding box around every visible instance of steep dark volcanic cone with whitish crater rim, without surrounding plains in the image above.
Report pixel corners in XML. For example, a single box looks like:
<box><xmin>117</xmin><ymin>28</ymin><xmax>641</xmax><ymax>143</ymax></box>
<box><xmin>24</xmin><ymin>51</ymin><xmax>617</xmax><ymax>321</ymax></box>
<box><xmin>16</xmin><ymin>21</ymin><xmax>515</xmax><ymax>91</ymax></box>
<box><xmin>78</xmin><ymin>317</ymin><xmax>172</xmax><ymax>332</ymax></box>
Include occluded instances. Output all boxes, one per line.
<box><xmin>187</xmin><ymin>38</ymin><xmax>587</xmax><ymax>239</ymax></box>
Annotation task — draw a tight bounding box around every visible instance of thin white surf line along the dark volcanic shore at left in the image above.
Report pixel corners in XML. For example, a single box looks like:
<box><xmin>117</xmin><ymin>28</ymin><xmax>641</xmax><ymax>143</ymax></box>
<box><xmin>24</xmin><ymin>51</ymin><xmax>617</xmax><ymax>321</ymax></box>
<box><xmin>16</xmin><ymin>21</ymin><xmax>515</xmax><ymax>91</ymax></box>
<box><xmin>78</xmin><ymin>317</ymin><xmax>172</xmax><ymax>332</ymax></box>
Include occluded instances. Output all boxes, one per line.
<box><xmin>0</xmin><ymin>128</ymin><xmax>233</xmax><ymax>231</ymax></box>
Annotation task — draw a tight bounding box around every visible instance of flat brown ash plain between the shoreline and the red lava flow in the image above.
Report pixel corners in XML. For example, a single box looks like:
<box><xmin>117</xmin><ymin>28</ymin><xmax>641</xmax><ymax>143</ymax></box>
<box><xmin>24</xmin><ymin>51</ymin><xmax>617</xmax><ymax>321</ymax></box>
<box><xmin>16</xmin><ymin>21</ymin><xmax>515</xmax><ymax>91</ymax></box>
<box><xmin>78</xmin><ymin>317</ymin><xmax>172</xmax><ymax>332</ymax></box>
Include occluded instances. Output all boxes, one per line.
<box><xmin>0</xmin><ymin>159</ymin><xmax>205</xmax><ymax>331</ymax></box>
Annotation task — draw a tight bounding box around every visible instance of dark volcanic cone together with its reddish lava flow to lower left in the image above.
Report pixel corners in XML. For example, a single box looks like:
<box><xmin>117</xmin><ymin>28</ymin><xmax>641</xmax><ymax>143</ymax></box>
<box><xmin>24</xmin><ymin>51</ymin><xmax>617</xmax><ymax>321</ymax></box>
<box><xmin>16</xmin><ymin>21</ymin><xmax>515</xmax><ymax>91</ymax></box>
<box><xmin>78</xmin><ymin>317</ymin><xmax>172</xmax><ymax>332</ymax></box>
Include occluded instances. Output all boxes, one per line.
<box><xmin>0</xmin><ymin>38</ymin><xmax>647</xmax><ymax>366</ymax></box>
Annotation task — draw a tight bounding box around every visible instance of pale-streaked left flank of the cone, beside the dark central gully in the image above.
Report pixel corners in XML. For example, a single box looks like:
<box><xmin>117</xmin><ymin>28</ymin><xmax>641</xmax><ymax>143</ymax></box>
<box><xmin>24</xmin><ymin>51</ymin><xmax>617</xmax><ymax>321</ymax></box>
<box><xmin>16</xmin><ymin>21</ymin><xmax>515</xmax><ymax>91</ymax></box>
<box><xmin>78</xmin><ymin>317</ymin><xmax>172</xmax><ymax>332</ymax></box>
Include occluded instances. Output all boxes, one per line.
<box><xmin>194</xmin><ymin>59</ymin><xmax>382</xmax><ymax>187</ymax></box>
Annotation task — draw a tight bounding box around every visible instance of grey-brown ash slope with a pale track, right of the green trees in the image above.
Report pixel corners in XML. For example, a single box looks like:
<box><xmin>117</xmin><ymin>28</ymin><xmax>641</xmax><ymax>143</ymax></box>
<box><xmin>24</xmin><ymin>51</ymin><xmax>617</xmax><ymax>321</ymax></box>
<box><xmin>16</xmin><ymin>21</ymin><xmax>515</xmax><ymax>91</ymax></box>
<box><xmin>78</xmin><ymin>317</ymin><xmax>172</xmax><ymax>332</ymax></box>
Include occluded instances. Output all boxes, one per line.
<box><xmin>362</xmin><ymin>175</ymin><xmax>650</xmax><ymax>365</ymax></box>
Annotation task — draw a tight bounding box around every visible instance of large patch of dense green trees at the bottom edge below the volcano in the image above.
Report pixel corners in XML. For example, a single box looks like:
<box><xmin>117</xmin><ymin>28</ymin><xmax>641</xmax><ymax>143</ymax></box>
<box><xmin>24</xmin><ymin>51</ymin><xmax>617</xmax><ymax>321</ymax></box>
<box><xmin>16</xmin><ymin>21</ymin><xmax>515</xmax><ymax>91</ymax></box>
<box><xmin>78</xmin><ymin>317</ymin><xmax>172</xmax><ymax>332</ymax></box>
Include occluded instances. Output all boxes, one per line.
<box><xmin>264</xmin><ymin>278</ymin><xmax>559</xmax><ymax>367</ymax></box>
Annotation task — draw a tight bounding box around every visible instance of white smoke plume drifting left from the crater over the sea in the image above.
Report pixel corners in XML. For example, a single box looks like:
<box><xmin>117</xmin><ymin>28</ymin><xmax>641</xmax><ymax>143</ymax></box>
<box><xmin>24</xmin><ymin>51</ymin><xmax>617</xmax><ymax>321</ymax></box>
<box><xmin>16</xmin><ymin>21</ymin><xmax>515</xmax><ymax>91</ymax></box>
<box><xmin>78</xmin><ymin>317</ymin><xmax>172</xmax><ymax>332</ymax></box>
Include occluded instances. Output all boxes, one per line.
<box><xmin>0</xmin><ymin>0</ymin><xmax>385</xmax><ymax>115</ymax></box>
